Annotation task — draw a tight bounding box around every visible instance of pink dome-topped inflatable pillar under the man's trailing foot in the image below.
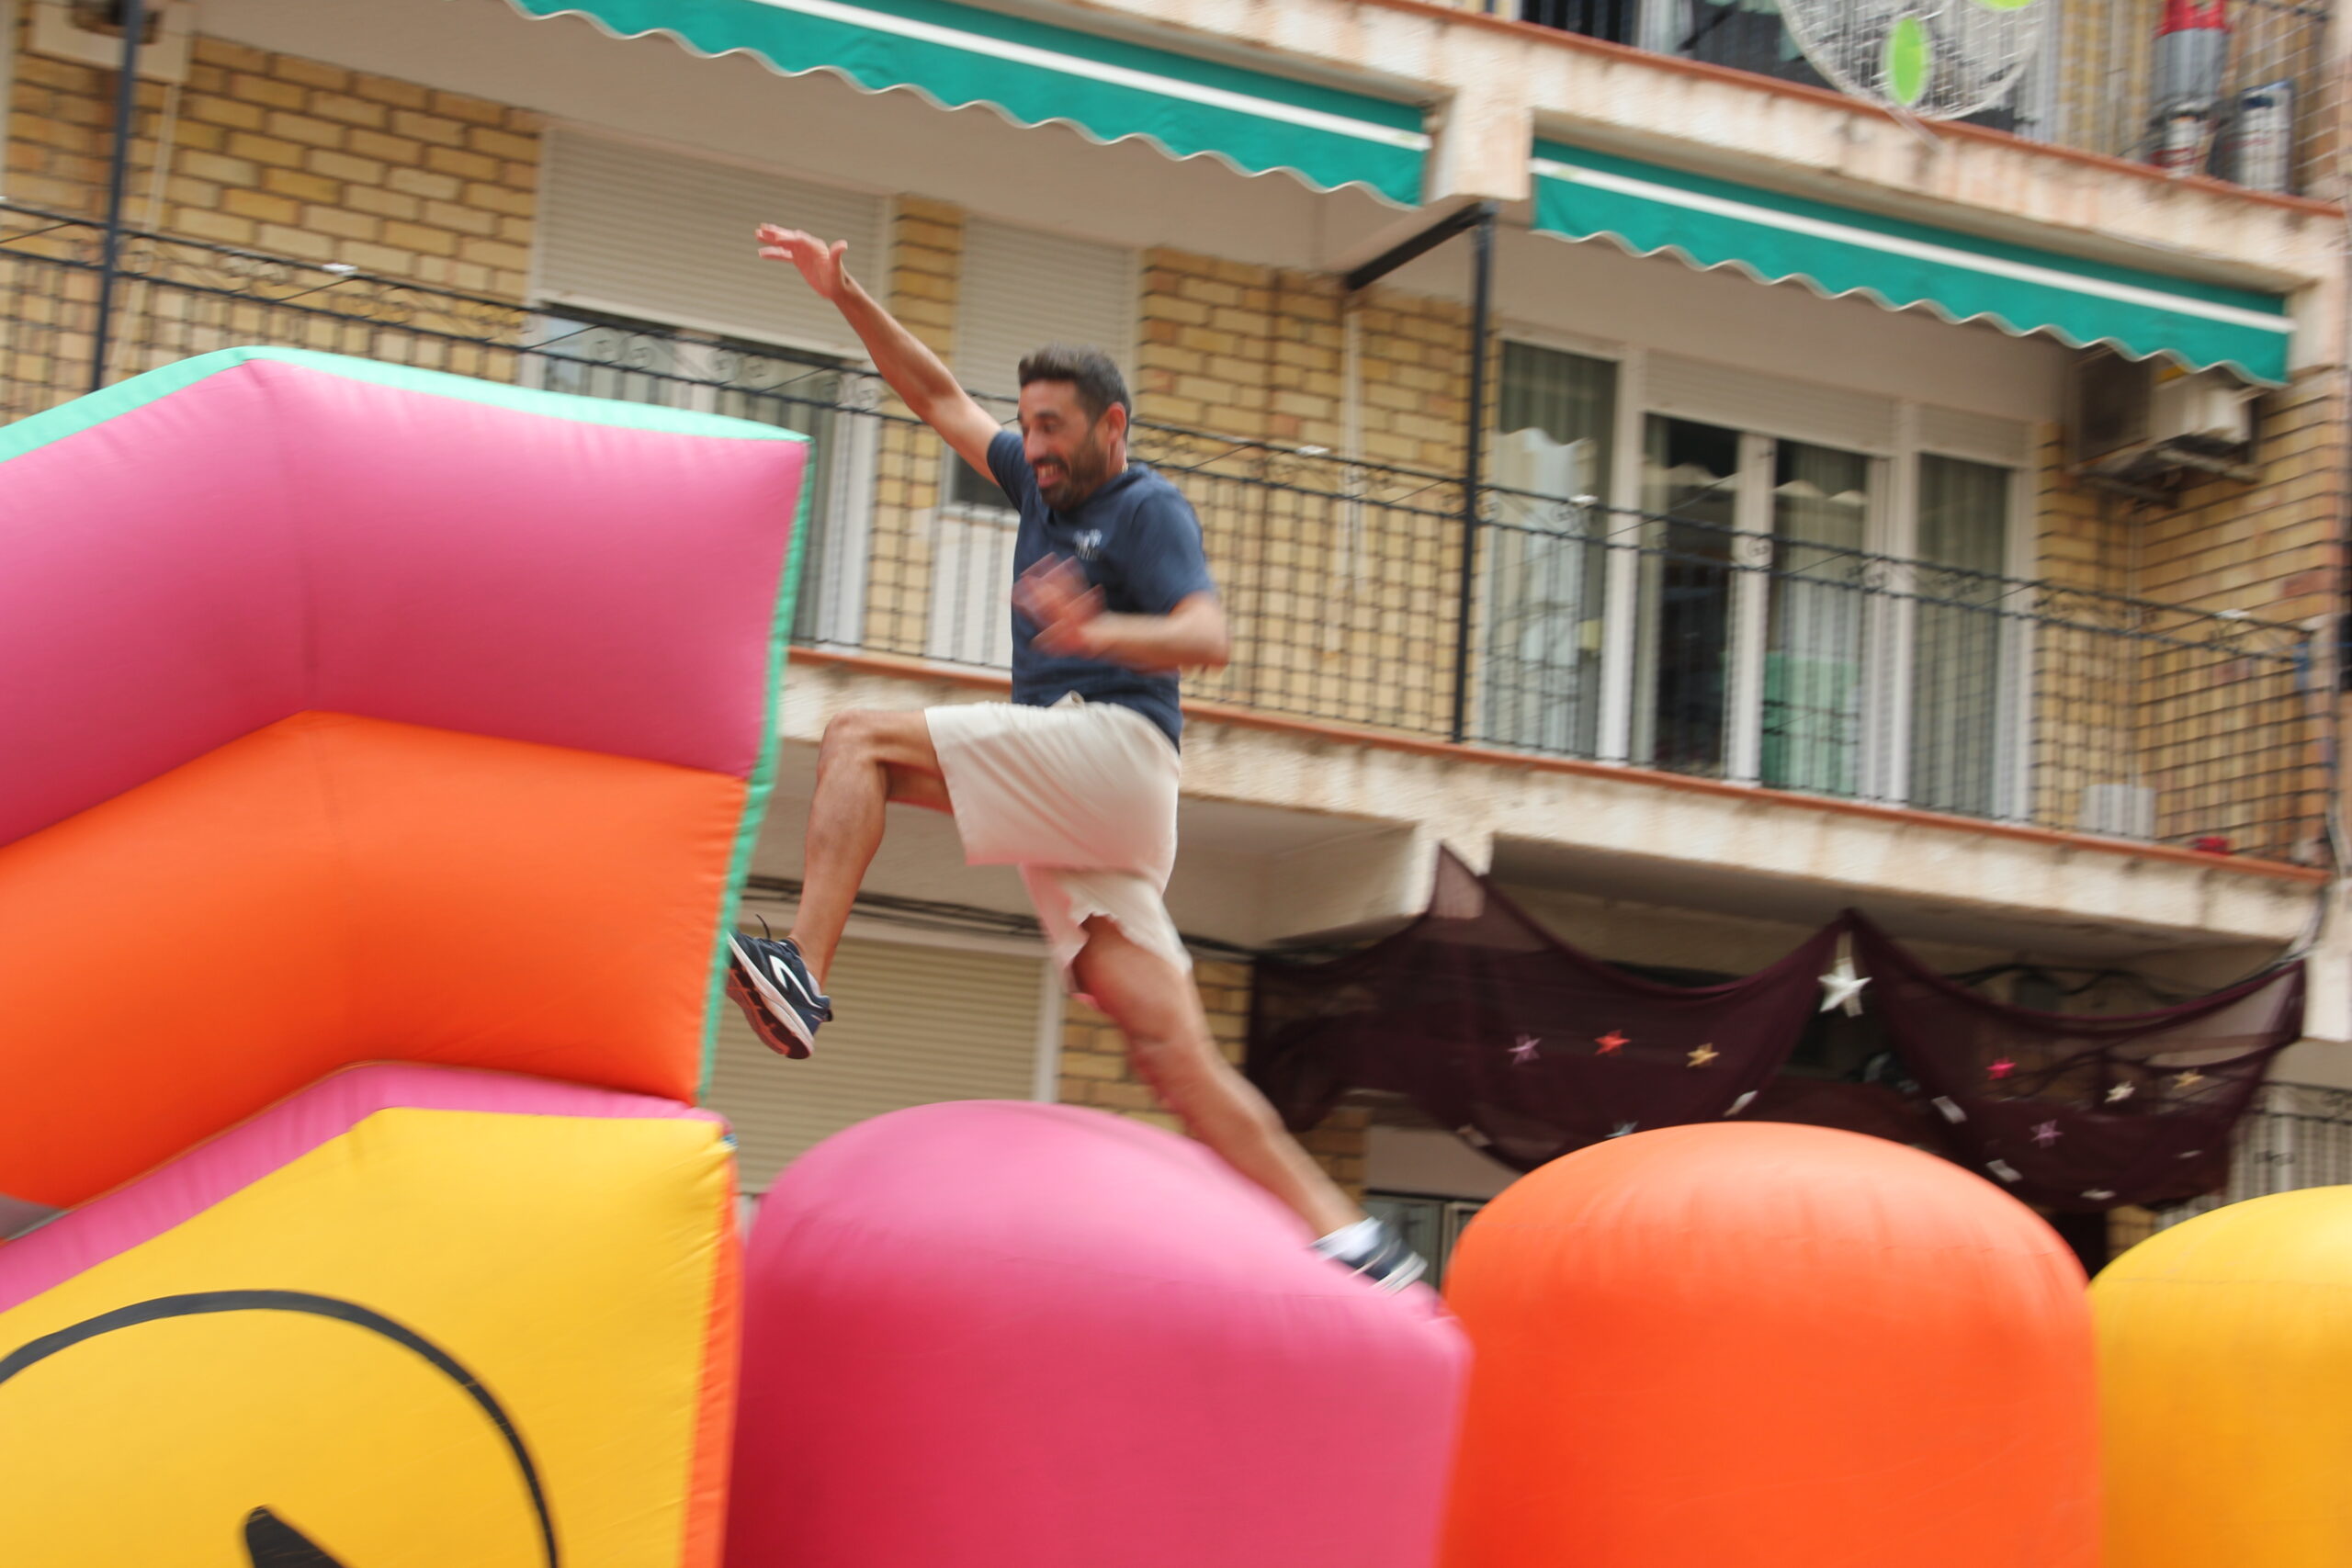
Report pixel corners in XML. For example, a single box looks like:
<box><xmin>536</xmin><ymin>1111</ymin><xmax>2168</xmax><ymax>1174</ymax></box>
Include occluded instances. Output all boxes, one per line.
<box><xmin>727</xmin><ymin>1100</ymin><xmax>1467</xmax><ymax>1568</ymax></box>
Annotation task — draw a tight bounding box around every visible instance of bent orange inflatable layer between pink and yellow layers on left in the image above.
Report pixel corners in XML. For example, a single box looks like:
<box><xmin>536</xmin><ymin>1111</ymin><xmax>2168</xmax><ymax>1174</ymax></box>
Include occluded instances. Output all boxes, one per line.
<box><xmin>0</xmin><ymin>712</ymin><xmax>746</xmax><ymax>1206</ymax></box>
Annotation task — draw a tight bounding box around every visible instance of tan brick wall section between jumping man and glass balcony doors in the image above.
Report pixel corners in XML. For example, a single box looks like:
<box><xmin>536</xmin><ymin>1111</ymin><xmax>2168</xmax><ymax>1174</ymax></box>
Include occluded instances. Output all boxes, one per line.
<box><xmin>1136</xmin><ymin>249</ymin><xmax>1467</xmax><ymax>731</ymax></box>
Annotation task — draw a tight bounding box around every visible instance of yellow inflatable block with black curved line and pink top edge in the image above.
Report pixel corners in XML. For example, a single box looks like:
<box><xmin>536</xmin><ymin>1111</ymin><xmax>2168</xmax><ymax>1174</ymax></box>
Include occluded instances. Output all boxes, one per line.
<box><xmin>0</xmin><ymin>1067</ymin><xmax>736</xmax><ymax>1568</ymax></box>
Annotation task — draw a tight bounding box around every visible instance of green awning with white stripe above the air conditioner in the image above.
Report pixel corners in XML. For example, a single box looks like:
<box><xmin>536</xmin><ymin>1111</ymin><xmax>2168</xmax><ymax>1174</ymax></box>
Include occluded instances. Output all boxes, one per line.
<box><xmin>1533</xmin><ymin>141</ymin><xmax>2293</xmax><ymax>386</ymax></box>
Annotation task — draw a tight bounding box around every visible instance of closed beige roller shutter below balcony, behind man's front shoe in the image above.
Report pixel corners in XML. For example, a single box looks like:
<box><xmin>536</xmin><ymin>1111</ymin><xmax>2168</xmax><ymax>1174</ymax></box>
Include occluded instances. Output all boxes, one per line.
<box><xmin>710</xmin><ymin>941</ymin><xmax>1046</xmax><ymax>1192</ymax></box>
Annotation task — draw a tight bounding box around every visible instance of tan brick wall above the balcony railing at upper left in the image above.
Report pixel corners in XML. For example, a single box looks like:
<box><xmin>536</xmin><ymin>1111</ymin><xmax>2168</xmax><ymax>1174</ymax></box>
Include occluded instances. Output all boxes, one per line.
<box><xmin>7</xmin><ymin>38</ymin><xmax>538</xmax><ymax>299</ymax></box>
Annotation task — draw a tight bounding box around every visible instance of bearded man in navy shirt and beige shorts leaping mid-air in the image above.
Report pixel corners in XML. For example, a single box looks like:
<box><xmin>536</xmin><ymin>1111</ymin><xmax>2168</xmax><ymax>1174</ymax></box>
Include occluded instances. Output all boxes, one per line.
<box><xmin>729</xmin><ymin>223</ymin><xmax>1425</xmax><ymax>1291</ymax></box>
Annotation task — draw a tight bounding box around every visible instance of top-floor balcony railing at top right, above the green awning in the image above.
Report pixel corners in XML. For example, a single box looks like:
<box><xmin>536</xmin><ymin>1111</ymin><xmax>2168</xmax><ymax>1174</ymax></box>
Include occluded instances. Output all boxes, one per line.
<box><xmin>1505</xmin><ymin>0</ymin><xmax>2338</xmax><ymax>195</ymax></box>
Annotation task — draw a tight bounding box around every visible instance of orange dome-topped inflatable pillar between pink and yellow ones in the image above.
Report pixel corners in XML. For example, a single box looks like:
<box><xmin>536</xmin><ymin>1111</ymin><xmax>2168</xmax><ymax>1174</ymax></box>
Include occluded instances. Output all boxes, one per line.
<box><xmin>1444</xmin><ymin>1123</ymin><xmax>2100</xmax><ymax>1568</ymax></box>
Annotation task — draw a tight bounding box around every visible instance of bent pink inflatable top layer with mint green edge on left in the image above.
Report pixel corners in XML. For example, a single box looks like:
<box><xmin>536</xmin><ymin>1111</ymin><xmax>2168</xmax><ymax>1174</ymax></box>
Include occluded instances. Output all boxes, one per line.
<box><xmin>0</xmin><ymin>348</ymin><xmax>807</xmax><ymax>844</ymax></box>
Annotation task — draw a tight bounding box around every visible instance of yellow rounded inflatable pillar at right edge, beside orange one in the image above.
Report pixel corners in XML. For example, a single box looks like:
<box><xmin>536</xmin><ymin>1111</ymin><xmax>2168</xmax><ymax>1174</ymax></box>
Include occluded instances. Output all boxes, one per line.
<box><xmin>2091</xmin><ymin>1187</ymin><xmax>2352</xmax><ymax>1568</ymax></box>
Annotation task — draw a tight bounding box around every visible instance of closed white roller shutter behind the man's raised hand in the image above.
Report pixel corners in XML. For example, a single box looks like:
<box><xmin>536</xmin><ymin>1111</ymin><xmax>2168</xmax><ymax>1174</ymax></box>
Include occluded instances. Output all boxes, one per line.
<box><xmin>538</xmin><ymin>131</ymin><xmax>885</xmax><ymax>360</ymax></box>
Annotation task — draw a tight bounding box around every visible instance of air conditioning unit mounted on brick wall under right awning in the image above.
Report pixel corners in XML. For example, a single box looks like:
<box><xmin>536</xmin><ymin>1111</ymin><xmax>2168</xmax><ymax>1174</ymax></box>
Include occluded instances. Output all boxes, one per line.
<box><xmin>2067</xmin><ymin>350</ymin><xmax>2256</xmax><ymax>484</ymax></box>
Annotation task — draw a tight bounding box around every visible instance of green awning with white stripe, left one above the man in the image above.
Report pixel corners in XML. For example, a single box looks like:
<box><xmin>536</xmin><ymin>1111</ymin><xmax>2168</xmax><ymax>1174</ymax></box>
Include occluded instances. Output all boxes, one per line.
<box><xmin>508</xmin><ymin>0</ymin><xmax>1430</xmax><ymax>207</ymax></box>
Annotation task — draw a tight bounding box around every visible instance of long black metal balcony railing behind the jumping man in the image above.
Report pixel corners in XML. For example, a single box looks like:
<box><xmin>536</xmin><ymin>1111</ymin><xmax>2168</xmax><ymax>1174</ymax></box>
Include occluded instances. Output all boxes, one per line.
<box><xmin>0</xmin><ymin>209</ymin><xmax>2326</xmax><ymax>863</ymax></box>
